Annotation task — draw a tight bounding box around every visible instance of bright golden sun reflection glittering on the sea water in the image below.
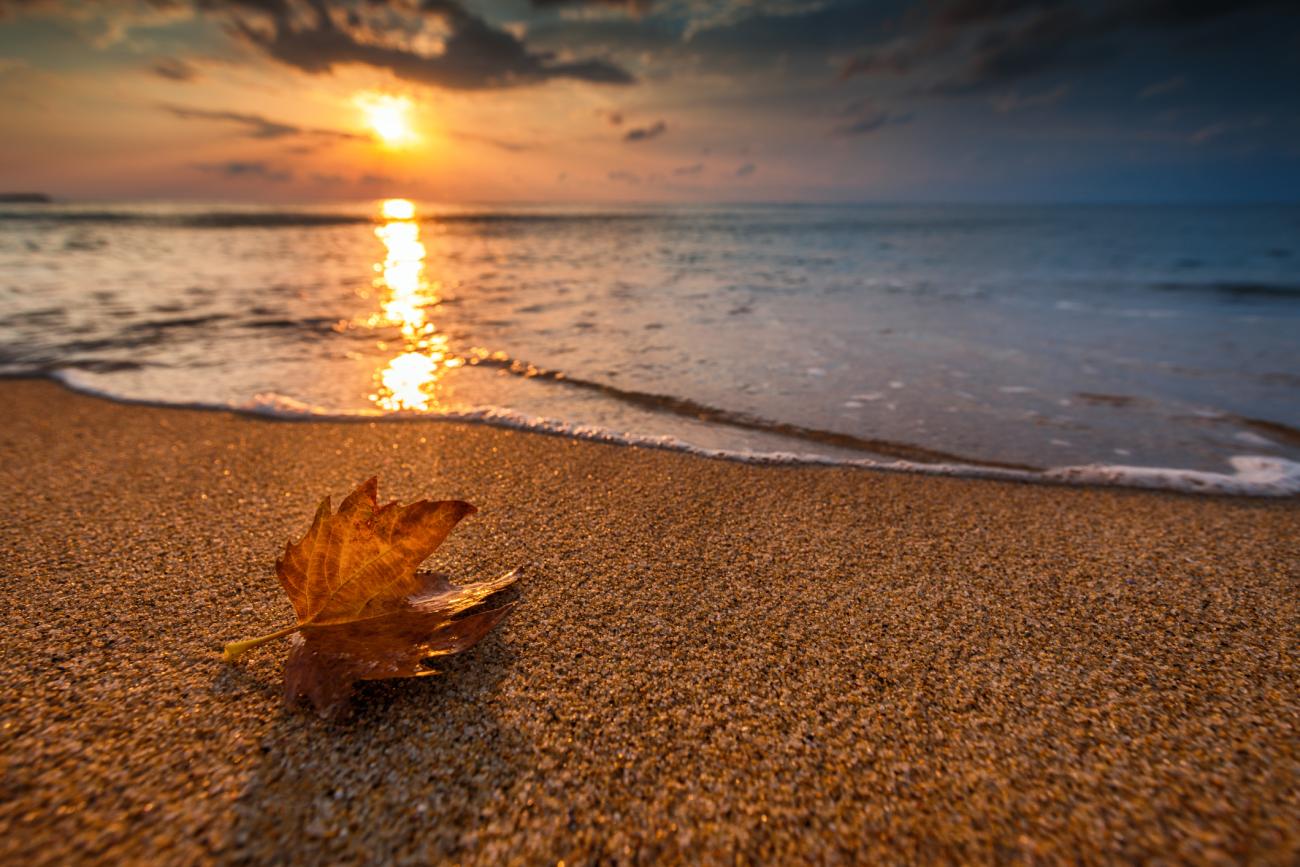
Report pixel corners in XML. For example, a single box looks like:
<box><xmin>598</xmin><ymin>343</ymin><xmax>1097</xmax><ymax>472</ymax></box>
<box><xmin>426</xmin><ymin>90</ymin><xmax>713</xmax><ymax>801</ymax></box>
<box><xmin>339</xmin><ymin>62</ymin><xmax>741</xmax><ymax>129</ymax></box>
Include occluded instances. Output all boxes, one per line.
<box><xmin>367</xmin><ymin>199</ymin><xmax>463</xmax><ymax>412</ymax></box>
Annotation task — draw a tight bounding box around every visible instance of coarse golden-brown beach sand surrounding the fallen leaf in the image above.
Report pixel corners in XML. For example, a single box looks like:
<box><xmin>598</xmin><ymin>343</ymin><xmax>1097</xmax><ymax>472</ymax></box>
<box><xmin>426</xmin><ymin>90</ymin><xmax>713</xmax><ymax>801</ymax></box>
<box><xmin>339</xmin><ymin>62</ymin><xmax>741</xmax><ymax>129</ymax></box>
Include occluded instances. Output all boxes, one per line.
<box><xmin>0</xmin><ymin>381</ymin><xmax>1300</xmax><ymax>864</ymax></box>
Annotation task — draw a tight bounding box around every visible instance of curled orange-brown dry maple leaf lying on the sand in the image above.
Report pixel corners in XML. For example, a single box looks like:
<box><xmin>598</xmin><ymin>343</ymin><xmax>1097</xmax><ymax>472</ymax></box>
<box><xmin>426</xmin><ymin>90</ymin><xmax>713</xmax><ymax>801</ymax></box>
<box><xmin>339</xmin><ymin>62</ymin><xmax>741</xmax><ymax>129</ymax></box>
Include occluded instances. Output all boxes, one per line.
<box><xmin>224</xmin><ymin>477</ymin><xmax>517</xmax><ymax>718</ymax></box>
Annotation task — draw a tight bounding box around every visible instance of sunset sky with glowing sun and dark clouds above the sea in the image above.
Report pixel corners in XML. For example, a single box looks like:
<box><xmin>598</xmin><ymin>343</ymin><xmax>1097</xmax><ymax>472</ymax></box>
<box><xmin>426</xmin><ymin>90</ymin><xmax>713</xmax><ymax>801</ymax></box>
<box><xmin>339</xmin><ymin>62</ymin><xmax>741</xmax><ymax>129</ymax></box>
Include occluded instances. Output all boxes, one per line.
<box><xmin>0</xmin><ymin>0</ymin><xmax>1300</xmax><ymax>203</ymax></box>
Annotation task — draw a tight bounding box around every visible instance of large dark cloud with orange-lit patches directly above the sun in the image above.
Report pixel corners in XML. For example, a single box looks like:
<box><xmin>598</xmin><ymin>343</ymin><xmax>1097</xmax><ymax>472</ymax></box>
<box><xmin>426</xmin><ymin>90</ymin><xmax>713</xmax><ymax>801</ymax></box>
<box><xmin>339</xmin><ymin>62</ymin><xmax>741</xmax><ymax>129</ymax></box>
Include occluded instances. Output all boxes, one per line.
<box><xmin>218</xmin><ymin>0</ymin><xmax>634</xmax><ymax>90</ymax></box>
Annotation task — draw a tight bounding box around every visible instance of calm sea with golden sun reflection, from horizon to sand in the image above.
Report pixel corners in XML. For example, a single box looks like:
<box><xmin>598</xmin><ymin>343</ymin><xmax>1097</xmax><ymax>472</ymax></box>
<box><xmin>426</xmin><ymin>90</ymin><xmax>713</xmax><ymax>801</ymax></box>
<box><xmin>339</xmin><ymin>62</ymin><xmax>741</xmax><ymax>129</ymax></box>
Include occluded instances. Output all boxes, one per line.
<box><xmin>0</xmin><ymin>200</ymin><xmax>1300</xmax><ymax>494</ymax></box>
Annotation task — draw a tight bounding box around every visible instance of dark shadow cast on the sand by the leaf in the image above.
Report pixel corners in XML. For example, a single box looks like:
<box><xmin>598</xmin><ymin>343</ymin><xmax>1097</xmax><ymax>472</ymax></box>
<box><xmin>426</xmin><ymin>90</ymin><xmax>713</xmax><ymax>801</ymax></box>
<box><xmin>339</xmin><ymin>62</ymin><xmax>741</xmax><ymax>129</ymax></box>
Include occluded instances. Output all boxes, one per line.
<box><xmin>228</xmin><ymin>634</ymin><xmax>528</xmax><ymax>863</ymax></box>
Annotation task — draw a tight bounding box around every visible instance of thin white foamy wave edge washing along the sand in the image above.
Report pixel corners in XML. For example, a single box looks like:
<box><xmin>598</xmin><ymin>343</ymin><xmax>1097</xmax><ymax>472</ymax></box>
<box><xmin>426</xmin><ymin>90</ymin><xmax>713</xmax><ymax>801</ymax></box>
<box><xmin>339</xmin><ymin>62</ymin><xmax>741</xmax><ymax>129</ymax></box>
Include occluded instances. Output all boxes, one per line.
<box><xmin>15</xmin><ymin>370</ymin><xmax>1300</xmax><ymax>499</ymax></box>
